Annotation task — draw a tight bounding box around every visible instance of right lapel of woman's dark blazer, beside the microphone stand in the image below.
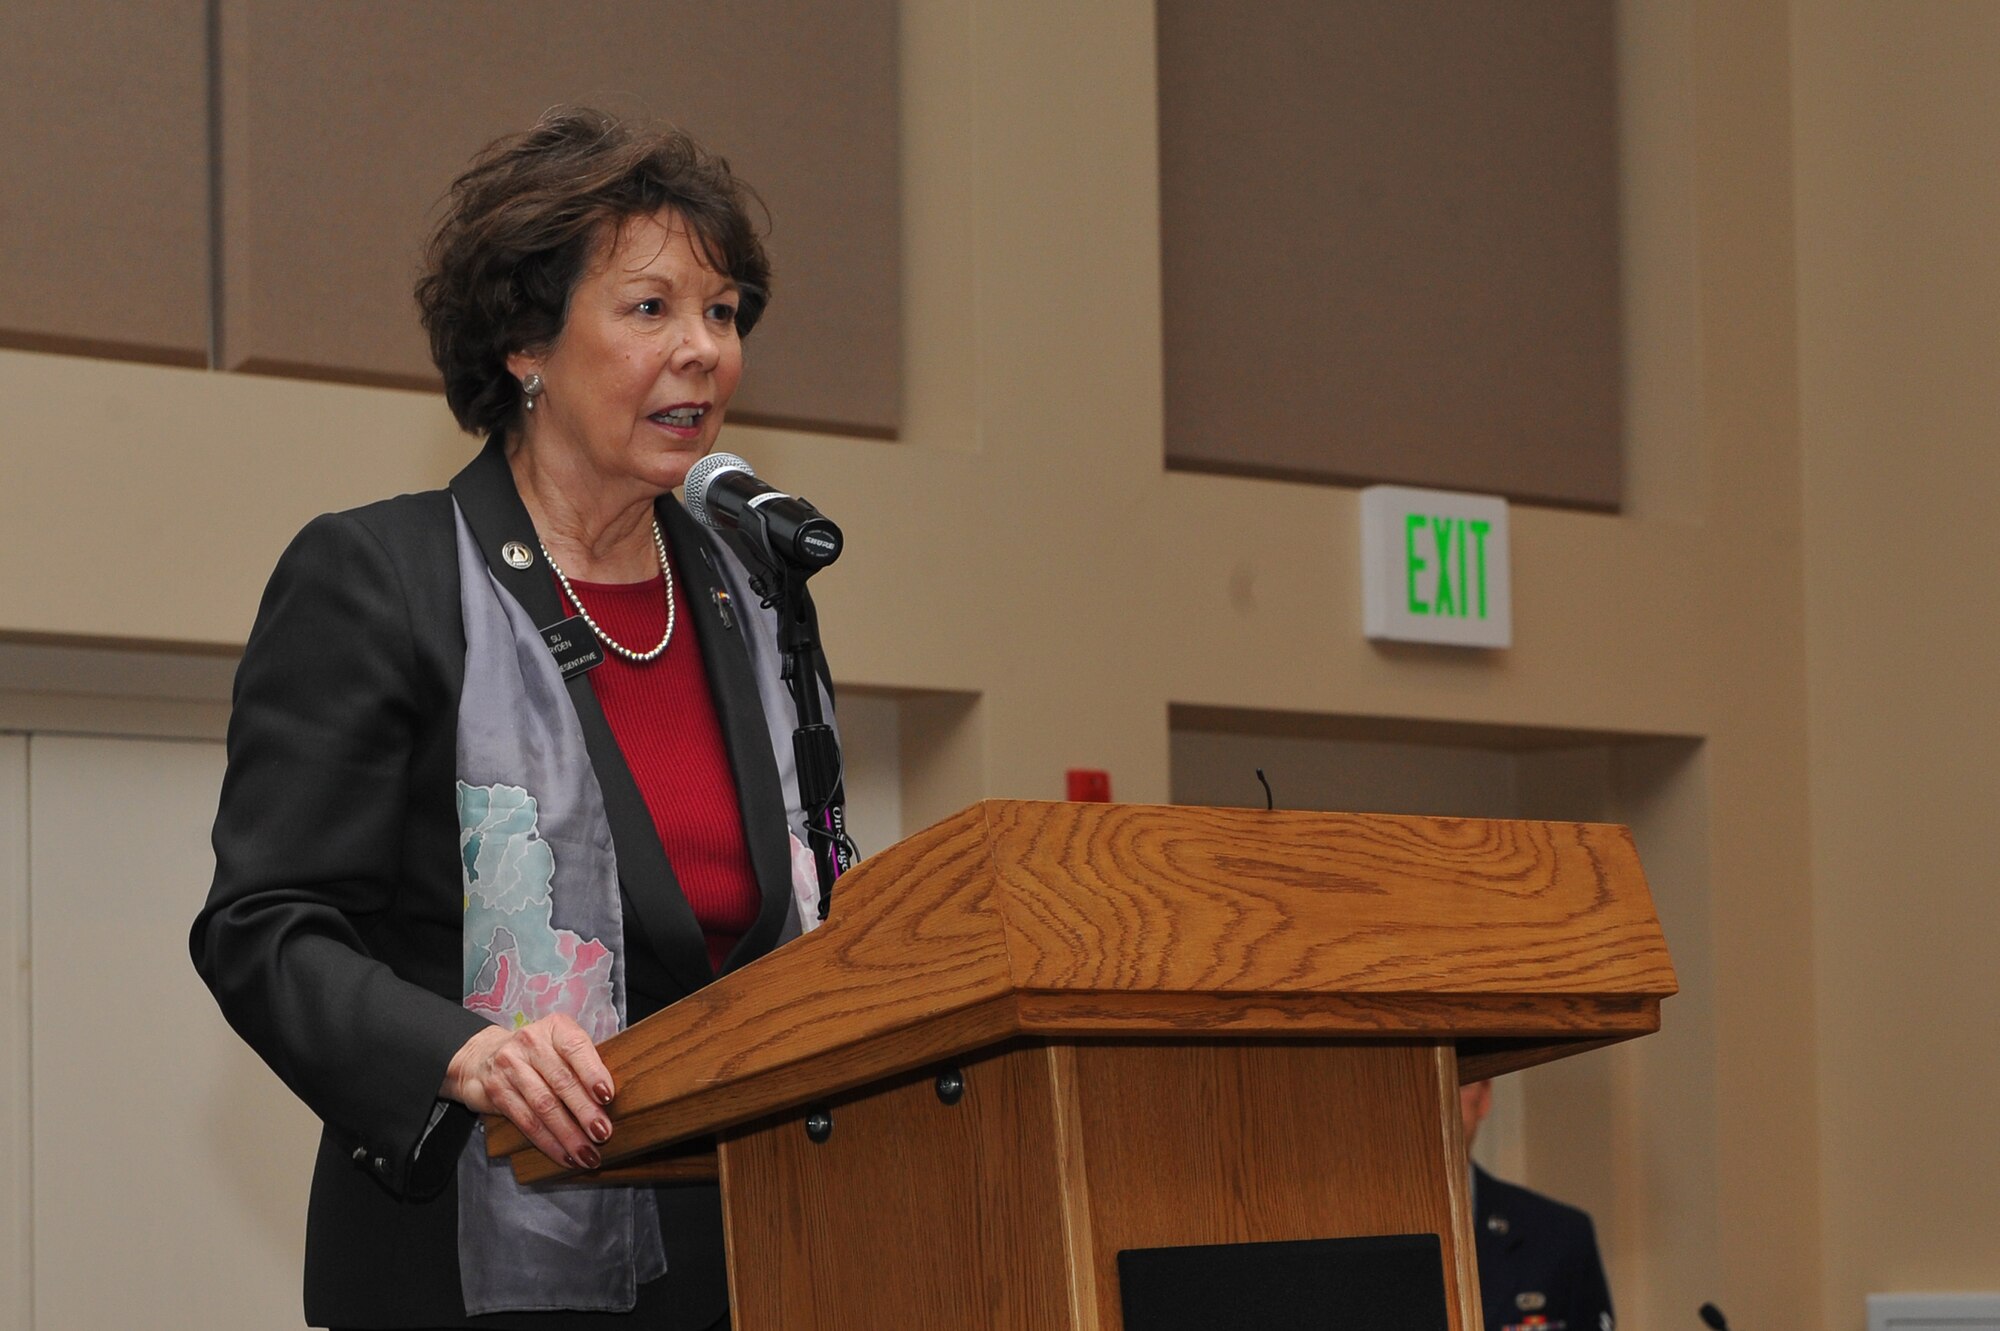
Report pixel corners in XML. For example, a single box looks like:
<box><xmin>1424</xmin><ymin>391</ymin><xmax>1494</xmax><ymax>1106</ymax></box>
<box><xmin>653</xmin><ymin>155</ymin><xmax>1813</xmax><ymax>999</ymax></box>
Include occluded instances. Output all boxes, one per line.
<box><xmin>656</xmin><ymin>496</ymin><xmax>792</xmax><ymax>973</ymax></box>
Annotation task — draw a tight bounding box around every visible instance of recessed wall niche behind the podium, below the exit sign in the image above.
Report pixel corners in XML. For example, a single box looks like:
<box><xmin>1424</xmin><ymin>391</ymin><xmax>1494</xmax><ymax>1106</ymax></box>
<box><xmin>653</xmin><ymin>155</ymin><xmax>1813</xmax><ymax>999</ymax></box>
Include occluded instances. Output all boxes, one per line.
<box><xmin>1170</xmin><ymin>705</ymin><xmax>1716</xmax><ymax>1307</ymax></box>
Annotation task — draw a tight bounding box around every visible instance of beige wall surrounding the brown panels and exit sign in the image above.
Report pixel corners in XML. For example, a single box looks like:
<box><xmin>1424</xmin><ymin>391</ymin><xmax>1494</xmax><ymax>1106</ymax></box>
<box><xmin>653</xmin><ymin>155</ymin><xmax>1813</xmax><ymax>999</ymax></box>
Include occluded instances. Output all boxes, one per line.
<box><xmin>0</xmin><ymin>0</ymin><xmax>2000</xmax><ymax>1331</ymax></box>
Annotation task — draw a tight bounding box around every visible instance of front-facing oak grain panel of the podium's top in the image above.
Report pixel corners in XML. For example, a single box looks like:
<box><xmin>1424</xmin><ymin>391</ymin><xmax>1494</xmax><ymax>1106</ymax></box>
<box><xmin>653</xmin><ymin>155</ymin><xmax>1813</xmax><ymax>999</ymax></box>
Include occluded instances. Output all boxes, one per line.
<box><xmin>986</xmin><ymin>801</ymin><xmax>1674</xmax><ymax>995</ymax></box>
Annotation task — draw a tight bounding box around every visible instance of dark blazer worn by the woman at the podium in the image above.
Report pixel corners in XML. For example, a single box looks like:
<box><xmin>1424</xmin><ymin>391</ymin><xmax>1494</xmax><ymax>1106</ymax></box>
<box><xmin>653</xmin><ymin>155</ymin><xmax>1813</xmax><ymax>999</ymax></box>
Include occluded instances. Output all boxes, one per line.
<box><xmin>188</xmin><ymin>440</ymin><xmax>792</xmax><ymax>1329</ymax></box>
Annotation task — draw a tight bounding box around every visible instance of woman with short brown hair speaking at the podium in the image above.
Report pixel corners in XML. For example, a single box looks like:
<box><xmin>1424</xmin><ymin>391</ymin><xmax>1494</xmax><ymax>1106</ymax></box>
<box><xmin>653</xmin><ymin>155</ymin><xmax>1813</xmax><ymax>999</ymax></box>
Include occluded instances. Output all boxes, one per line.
<box><xmin>190</xmin><ymin>110</ymin><xmax>828</xmax><ymax>1329</ymax></box>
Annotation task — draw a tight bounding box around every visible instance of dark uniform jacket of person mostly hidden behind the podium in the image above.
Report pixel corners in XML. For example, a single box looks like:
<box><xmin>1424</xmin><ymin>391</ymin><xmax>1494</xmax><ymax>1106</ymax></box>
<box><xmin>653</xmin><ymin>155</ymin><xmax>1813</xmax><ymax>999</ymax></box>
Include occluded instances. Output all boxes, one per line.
<box><xmin>1472</xmin><ymin>1165</ymin><xmax>1614</xmax><ymax>1331</ymax></box>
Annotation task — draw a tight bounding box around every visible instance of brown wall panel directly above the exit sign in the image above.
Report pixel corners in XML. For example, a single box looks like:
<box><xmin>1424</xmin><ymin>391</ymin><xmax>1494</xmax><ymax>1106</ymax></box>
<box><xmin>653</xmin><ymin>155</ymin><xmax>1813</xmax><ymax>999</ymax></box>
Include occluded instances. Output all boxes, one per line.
<box><xmin>1158</xmin><ymin>0</ymin><xmax>1622</xmax><ymax>508</ymax></box>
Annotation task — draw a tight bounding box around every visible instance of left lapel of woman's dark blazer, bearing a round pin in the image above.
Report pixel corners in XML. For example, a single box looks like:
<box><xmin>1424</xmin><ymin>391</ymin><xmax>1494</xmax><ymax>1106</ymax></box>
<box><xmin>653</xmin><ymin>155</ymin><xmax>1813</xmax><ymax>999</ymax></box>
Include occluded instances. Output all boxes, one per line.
<box><xmin>452</xmin><ymin>436</ymin><xmax>720</xmax><ymax>993</ymax></box>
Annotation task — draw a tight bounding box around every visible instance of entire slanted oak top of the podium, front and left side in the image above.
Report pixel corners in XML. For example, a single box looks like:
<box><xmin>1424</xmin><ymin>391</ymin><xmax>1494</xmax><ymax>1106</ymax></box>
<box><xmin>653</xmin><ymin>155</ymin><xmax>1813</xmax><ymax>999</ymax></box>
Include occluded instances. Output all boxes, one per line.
<box><xmin>488</xmin><ymin>799</ymin><xmax>1674</xmax><ymax>1181</ymax></box>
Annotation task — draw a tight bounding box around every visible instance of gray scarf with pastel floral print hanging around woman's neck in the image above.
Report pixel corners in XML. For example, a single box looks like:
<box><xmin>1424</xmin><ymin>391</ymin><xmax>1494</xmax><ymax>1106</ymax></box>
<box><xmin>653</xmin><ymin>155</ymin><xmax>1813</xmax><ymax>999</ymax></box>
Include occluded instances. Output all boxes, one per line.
<box><xmin>454</xmin><ymin>506</ymin><xmax>832</xmax><ymax>1315</ymax></box>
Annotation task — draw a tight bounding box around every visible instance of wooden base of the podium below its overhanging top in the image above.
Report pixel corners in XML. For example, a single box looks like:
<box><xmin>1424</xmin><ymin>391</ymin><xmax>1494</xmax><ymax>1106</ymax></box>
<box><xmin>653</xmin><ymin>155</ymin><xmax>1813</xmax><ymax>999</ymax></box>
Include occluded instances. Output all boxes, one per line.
<box><xmin>720</xmin><ymin>1041</ymin><xmax>1480</xmax><ymax>1331</ymax></box>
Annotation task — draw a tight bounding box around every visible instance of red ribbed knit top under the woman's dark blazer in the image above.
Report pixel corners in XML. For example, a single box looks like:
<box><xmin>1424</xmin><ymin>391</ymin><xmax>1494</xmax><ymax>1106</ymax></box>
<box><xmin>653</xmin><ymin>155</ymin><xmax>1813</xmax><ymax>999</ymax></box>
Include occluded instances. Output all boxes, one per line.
<box><xmin>558</xmin><ymin>555</ymin><xmax>762</xmax><ymax>971</ymax></box>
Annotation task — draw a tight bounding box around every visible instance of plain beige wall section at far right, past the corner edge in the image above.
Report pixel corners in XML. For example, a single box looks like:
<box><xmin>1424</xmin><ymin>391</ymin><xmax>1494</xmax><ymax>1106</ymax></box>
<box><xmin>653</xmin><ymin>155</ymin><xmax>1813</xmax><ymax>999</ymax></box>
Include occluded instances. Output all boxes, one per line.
<box><xmin>1792</xmin><ymin>0</ymin><xmax>2000</xmax><ymax>1327</ymax></box>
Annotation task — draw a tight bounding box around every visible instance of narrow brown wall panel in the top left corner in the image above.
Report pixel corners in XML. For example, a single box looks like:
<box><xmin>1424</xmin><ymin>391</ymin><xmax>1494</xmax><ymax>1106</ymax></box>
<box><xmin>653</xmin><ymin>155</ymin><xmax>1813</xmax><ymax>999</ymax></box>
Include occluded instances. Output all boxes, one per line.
<box><xmin>0</xmin><ymin>0</ymin><xmax>208</xmax><ymax>364</ymax></box>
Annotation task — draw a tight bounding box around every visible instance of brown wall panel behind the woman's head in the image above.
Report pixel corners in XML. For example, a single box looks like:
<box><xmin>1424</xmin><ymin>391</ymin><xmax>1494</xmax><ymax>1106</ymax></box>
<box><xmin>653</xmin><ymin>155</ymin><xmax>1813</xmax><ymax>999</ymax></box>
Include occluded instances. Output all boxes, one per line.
<box><xmin>222</xmin><ymin>0</ymin><xmax>902</xmax><ymax>434</ymax></box>
